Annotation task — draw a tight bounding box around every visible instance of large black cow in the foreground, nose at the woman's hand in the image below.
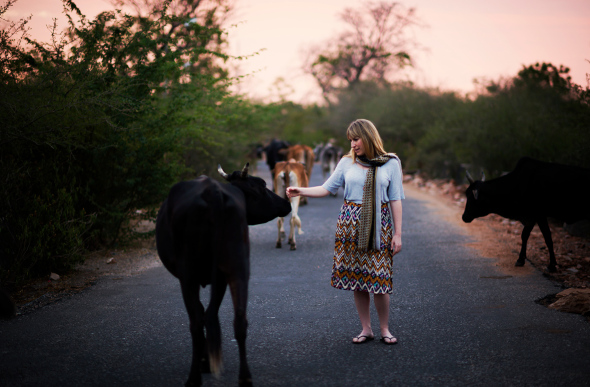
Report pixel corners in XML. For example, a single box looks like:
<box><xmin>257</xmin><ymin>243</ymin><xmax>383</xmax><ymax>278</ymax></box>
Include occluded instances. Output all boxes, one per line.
<box><xmin>156</xmin><ymin>164</ymin><xmax>291</xmax><ymax>386</ymax></box>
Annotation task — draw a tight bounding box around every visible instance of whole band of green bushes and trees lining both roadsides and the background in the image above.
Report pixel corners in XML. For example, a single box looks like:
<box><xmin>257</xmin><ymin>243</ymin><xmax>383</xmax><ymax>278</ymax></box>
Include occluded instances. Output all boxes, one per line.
<box><xmin>0</xmin><ymin>0</ymin><xmax>590</xmax><ymax>288</ymax></box>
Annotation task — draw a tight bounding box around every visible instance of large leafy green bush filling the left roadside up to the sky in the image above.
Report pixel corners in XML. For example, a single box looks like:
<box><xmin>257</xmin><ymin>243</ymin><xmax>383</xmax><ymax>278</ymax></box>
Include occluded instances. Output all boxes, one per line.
<box><xmin>0</xmin><ymin>1</ymin><xmax>245</xmax><ymax>284</ymax></box>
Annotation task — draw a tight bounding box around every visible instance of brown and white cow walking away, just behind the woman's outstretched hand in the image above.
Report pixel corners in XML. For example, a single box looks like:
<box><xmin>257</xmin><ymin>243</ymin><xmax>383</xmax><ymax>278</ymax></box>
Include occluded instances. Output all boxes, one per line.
<box><xmin>274</xmin><ymin>159</ymin><xmax>309</xmax><ymax>250</ymax></box>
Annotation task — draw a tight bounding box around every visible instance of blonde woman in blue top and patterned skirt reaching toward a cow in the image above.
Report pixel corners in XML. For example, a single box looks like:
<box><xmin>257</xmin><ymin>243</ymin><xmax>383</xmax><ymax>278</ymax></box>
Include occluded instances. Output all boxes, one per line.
<box><xmin>287</xmin><ymin>119</ymin><xmax>405</xmax><ymax>344</ymax></box>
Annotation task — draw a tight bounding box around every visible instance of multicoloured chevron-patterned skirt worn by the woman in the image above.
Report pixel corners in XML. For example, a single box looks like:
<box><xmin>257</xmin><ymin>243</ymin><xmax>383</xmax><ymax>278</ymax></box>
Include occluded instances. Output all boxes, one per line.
<box><xmin>332</xmin><ymin>201</ymin><xmax>393</xmax><ymax>294</ymax></box>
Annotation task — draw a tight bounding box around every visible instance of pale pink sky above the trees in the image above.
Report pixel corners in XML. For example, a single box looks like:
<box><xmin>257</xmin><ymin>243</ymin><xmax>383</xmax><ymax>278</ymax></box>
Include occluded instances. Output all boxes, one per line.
<box><xmin>6</xmin><ymin>0</ymin><xmax>590</xmax><ymax>103</ymax></box>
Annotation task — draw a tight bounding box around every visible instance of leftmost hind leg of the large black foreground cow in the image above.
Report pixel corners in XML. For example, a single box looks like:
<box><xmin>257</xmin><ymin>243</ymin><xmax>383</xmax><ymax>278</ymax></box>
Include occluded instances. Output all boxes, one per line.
<box><xmin>180</xmin><ymin>279</ymin><xmax>208</xmax><ymax>386</ymax></box>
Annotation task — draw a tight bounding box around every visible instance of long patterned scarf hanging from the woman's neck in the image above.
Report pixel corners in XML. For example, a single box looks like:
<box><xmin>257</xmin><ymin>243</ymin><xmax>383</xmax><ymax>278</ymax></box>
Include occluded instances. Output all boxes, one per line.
<box><xmin>357</xmin><ymin>153</ymin><xmax>401</xmax><ymax>251</ymax></box>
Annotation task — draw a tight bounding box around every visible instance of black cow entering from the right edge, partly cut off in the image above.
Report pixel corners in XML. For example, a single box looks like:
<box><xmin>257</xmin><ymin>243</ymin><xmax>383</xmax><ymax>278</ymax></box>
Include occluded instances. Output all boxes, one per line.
<box><xmin>463</xmin><ymin>157</ymin><xmax>590</xmax><ymax>271</ymax></box>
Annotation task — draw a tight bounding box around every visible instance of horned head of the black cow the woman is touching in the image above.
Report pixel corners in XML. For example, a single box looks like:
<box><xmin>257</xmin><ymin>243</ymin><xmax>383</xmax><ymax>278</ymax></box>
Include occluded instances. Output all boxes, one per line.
<box><xmin>217</xmin><ymin>163</ymin><xmax>291</xmax><ymax>225</ymax></box>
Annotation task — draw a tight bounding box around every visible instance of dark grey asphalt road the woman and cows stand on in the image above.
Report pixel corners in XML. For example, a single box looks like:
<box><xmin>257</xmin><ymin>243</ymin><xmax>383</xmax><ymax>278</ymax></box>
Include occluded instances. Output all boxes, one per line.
<box><xmin>0</xmin><ymin>162</ymin><xmax>590</xmax><ymax>387</ymax></box>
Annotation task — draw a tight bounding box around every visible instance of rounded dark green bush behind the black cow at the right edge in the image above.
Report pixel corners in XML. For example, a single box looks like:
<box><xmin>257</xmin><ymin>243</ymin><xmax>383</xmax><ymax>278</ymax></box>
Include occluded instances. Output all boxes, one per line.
<box><xmin>463</xmin><ymin>64</ymin><xmax>590</xmax><ymax>176</ymax></box>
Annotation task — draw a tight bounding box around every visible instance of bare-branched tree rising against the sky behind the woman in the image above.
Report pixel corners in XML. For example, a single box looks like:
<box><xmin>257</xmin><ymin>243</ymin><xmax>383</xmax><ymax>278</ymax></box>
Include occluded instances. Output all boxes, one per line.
<box><xmin>304</xmin><ymin>2</ymin><xmax>419</xmax><ymax>104</ymax></box>
